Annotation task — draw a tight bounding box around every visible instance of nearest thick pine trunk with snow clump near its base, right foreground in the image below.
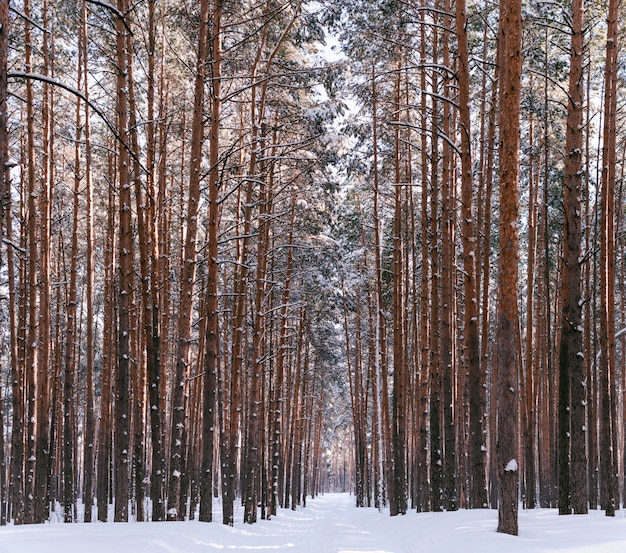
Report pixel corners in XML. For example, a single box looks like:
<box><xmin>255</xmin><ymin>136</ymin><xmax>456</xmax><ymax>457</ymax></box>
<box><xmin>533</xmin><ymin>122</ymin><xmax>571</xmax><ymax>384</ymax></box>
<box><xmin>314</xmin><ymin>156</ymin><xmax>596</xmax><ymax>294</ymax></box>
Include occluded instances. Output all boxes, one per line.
<box><xmin>496</xmin><ymin>0</ymin><xmax>522</xmax><ymax>535</ymax></box>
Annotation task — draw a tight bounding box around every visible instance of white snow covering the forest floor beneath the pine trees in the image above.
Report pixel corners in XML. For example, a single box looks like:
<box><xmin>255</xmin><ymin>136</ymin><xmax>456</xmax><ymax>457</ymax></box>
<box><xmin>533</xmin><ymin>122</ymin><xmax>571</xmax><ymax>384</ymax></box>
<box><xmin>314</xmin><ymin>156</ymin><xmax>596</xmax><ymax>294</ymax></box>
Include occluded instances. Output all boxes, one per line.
<box><xmin>0</xmin><ymin>494</ymin><xmax>626</xmax><ymax>553</ymax></box>
